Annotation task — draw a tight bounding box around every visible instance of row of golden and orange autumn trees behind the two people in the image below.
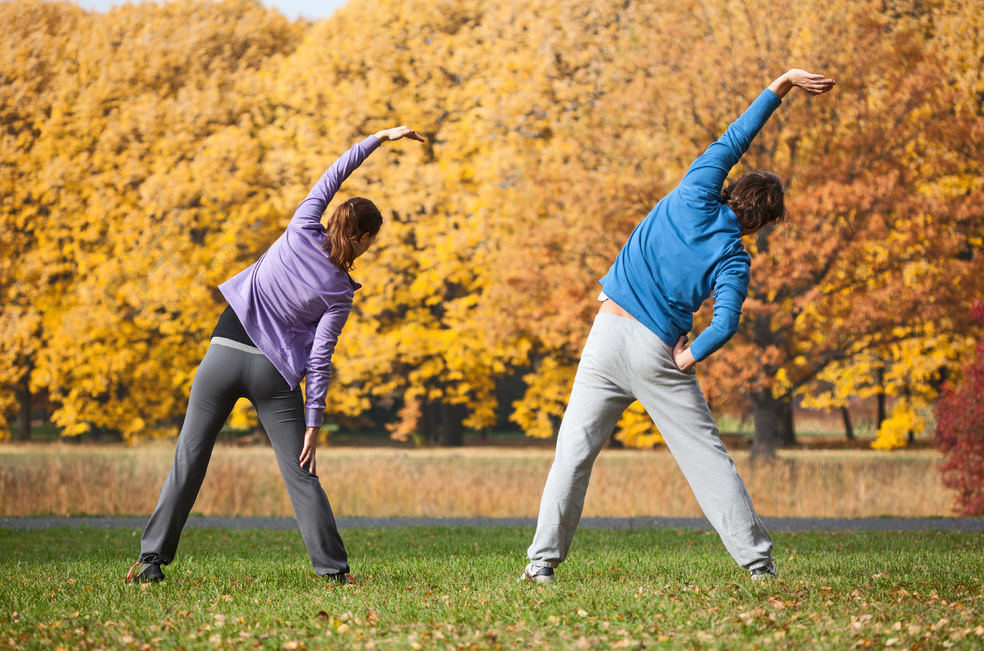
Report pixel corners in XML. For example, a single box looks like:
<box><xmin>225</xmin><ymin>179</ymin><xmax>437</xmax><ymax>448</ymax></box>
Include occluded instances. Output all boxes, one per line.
<box><xmin>0</xmin><ymin>0</ymin><xmax>984</xmax><ymax>453</ymax></box>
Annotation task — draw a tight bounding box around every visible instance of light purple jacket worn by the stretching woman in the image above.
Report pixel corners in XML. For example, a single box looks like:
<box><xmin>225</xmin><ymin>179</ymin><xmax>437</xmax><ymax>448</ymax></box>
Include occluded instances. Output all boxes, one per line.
<box><xmin>219</xmin><ymin>136</ymin><xmax>380</xmax><ymax>427</ymax></box>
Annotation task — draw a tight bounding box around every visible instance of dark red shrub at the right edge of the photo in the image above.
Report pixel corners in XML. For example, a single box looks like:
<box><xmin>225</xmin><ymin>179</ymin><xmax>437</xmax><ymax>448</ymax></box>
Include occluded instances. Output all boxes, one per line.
<box><xmin>936</xmin><ymin>302</ymin><xmax>984</xmax><ymax>515</ymax></box>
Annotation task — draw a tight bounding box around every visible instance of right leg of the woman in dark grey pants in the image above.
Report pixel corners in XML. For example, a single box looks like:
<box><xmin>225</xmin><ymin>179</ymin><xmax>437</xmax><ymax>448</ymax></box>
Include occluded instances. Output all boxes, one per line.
<box><xmin>247</xmin><ymin>355</ymin><xmax>349</xmax><ymax>575</ymax></box>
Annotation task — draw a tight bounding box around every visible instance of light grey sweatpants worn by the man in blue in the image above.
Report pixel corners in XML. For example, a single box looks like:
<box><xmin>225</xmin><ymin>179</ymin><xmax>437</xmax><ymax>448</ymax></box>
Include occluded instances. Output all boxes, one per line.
<box><xmin>527</xmin><ymin>313</ymin><xmax>773</xmax><ymax>570</ymax></box>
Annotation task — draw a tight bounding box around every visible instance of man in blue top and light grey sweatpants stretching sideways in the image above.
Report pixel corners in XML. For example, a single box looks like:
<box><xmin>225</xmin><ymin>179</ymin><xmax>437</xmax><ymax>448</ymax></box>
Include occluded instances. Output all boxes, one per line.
<box><xmin>520</xmin><ymin>69</ymin><xmax>834</xmax><ymax>583</ymax></box>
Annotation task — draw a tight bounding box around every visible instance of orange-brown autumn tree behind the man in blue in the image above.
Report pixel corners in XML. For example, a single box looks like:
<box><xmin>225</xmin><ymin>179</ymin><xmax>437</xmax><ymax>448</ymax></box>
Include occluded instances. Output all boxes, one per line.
<box><xmin>500</xmin><ymin>2</ymin><xmax>981</xmax><ymax>455</ymax></box>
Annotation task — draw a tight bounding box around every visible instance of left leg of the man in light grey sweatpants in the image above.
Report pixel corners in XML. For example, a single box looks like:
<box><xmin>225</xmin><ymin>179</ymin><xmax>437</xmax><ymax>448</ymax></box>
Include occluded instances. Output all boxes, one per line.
<box><xmin>527</xmin><ymin>315</ymin><xmax>634</xmax><ymax>567</ymax></box>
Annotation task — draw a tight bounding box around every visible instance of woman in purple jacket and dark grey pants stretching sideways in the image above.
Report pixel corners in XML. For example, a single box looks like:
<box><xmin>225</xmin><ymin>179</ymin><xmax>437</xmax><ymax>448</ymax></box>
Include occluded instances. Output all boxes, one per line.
<box><xmin>127</xmin><ymin>126</ymin><xmax>424</xmax><ymax>583</ymax></box>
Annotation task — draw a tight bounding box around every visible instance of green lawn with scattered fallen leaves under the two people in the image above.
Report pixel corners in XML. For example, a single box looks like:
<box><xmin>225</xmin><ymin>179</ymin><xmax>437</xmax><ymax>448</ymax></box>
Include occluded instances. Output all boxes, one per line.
<box><xmin>0</xmin><ymin>528</ymin><xmax>984</xmax><ymax>651</ymax></box>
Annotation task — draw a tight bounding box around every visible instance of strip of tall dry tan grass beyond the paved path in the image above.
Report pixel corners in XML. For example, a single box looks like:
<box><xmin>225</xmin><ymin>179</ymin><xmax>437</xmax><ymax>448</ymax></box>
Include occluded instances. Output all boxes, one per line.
<box><xmin>0</xmin><ymin>441</ymin><xmax>953</xmax><ymax>518</ymax></box>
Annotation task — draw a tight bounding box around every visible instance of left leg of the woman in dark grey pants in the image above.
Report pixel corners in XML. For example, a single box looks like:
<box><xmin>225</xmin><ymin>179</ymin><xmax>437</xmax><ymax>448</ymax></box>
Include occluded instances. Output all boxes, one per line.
<box><xmin>140</xmin><ymin>345</ymin><xmax>248</xmax><ymax>565</ymax></box>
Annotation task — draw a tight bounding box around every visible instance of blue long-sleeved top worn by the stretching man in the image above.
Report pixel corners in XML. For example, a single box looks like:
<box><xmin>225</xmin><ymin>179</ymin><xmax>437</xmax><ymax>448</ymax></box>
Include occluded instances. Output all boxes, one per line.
<box><xmin>600</xmin><ymin>89</ymin><xmax>781</xmax><ymax>361</ymax></box>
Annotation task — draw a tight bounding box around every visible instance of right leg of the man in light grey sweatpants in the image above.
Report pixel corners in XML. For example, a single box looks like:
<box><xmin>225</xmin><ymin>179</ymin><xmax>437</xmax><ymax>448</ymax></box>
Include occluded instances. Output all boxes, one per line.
<box><xmin>632</xmin><ymin>328</ymin><xmax>773</xmax><ymax>570</ymax></box>
